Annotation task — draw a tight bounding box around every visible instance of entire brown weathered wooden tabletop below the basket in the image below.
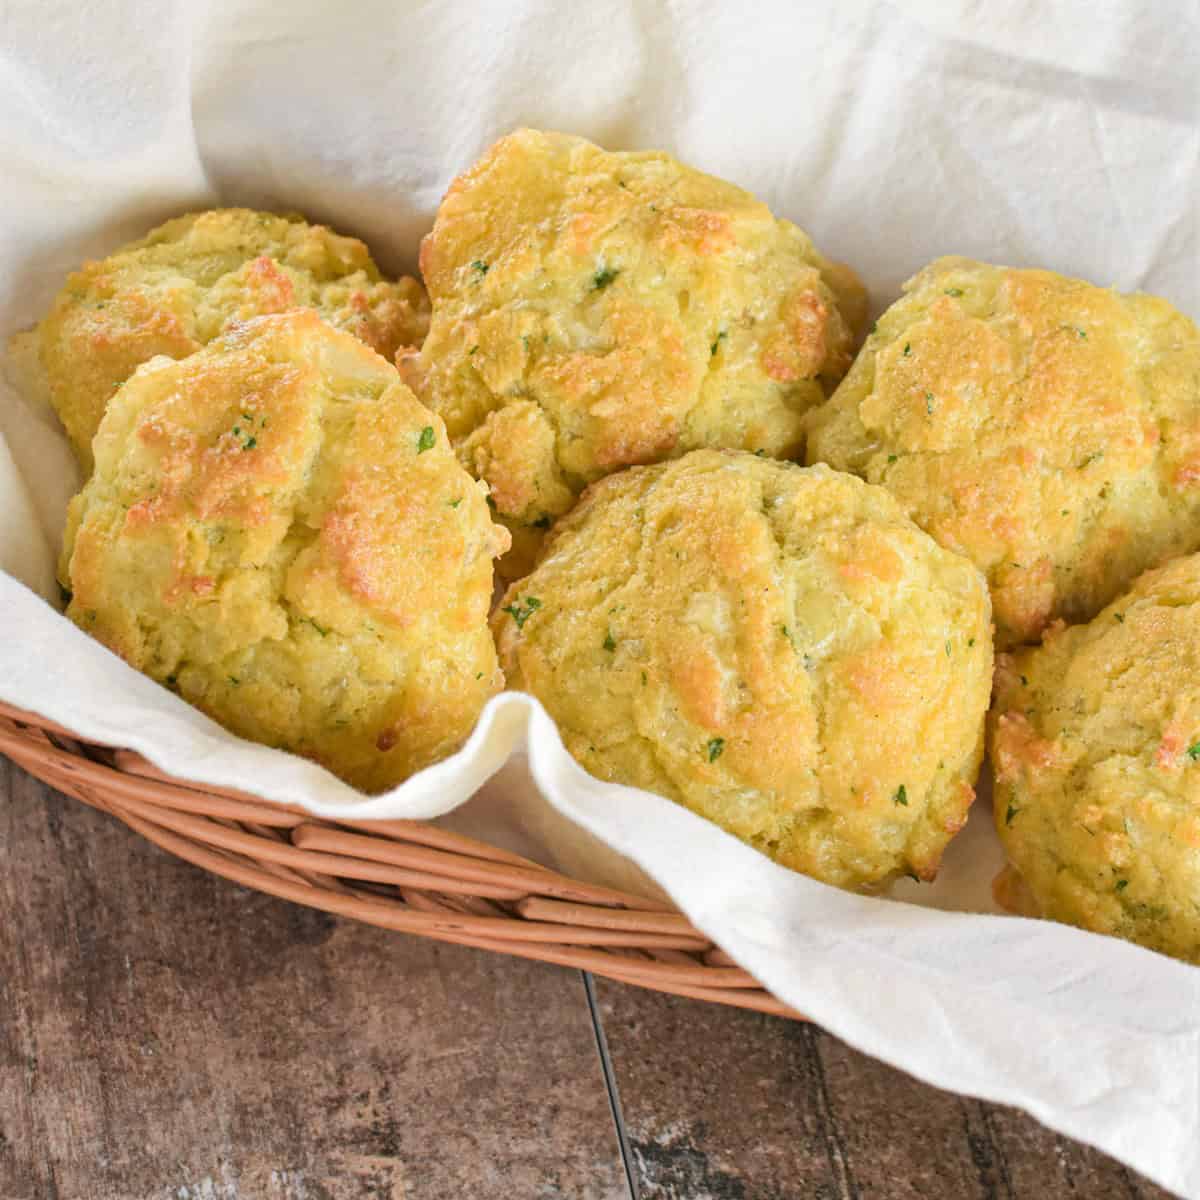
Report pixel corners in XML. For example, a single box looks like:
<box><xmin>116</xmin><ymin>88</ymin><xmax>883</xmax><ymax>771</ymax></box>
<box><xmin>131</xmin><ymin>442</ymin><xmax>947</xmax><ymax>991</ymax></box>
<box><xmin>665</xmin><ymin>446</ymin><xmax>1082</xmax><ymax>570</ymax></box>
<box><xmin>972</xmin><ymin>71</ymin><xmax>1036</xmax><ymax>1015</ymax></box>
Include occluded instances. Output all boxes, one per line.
<box><xmin>0</xmin><ymin>758</ymin><xmax>1166</xmax><ymax>1200</ymax></box>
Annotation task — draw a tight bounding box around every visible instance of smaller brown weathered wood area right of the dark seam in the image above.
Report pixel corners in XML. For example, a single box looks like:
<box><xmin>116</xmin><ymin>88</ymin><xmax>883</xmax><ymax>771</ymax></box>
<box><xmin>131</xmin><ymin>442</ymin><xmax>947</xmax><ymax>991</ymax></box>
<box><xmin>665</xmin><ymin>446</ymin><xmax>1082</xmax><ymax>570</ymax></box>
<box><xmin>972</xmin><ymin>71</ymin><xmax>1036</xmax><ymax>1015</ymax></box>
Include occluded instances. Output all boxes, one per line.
<box><xmin>596</xmin><ymin>980</ymin><xmax>1169</xmax><ymax>1200</ymax></box>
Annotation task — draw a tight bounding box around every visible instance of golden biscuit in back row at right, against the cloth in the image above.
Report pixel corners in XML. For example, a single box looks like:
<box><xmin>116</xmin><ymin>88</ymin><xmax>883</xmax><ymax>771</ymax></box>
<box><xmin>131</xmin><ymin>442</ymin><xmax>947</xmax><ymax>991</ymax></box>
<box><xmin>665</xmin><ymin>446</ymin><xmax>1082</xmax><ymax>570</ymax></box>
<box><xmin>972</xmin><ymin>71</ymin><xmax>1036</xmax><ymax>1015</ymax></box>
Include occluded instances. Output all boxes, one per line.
<box><xmin>808</xmin><ymin>258</ymin><xmax>1200</xmax><ymax>646</ymax></box>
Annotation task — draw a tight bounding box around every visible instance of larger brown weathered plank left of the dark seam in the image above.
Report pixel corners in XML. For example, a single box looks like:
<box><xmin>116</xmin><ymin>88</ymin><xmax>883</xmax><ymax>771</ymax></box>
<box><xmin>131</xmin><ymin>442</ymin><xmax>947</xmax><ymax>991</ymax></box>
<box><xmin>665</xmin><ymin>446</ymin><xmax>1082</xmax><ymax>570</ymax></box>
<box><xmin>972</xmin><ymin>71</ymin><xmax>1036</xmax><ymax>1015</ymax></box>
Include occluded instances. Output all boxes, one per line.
<box><xmin>0</xmin><ymin>760</ymin><xmax>628</xmax><ymax>1200</ymax></box>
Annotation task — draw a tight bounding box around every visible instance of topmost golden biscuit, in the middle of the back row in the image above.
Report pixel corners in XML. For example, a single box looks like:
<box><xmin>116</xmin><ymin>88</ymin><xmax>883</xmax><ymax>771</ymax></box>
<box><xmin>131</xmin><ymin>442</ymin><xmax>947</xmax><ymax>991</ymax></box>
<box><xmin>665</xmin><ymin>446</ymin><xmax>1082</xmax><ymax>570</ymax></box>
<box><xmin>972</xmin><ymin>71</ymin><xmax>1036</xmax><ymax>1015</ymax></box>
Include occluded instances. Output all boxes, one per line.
<box><xmin>401</xmin><ymin>130</ymin><xmax>865</xmax><ymax>569</ymax></box>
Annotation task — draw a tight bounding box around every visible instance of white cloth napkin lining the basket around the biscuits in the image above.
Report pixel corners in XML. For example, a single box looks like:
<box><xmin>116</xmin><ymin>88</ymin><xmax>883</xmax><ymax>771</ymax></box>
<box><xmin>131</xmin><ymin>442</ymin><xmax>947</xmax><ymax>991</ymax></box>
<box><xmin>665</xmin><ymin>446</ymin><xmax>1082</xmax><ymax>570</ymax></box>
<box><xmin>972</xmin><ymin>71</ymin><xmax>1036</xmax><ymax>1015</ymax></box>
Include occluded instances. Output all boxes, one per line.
<box><xmin>0</xmin><ymin>0</ymin><xmax>1200</xmax><ymax>1196</ymax></box>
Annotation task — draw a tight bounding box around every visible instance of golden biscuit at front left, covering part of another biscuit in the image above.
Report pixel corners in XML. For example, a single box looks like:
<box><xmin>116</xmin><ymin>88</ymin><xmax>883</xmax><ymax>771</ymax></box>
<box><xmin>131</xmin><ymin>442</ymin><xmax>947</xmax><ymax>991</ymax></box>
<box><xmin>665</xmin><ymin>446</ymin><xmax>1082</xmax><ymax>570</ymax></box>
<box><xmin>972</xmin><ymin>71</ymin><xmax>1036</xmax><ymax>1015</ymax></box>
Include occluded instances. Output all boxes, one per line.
<box><xmin>62</xmin><ymin>310</ymin><xmax>508</xmax><ymax>791</ymax></box>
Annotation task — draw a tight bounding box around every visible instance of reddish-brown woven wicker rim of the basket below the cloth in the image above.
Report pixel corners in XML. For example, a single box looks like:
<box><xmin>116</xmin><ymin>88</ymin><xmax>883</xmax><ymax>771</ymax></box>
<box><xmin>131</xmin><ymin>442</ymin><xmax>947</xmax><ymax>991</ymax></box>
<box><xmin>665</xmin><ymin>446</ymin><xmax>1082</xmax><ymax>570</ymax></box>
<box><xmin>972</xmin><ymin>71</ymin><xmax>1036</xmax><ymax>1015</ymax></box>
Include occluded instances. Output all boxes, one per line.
<box><xmin>0</xmin><ymin>702</ymin><xmax>803</xmax><ymax>1020</ymax></box>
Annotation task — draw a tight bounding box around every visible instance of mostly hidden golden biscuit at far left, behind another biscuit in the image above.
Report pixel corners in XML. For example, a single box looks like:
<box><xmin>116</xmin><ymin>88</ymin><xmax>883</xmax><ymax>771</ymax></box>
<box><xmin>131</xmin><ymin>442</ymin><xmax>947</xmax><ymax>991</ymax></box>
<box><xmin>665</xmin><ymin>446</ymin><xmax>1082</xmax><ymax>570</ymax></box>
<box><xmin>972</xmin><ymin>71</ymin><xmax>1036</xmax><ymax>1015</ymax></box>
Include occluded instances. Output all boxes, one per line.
<box><xmin>25</xmin><ymin>209</ymin><xmax>428</xmax><ymax>472</ymax></box>
